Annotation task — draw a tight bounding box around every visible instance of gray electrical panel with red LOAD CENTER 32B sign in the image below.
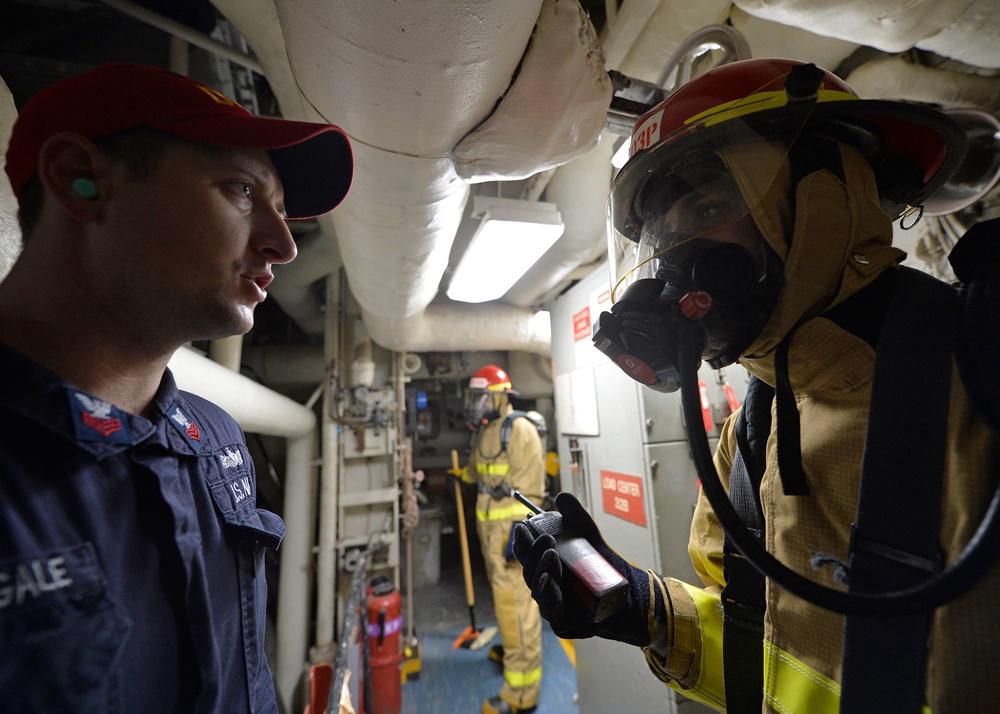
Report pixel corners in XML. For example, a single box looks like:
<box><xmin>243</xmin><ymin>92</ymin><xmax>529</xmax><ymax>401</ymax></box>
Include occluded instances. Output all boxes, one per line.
<box><xmin>549</xmin><ymin>267</ymin><xmax>749</xmax><ymax>714</ymax></box>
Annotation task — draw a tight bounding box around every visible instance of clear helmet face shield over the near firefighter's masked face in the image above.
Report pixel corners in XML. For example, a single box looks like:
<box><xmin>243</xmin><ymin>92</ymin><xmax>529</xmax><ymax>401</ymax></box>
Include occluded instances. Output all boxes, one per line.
<box><xmin>594</xmin><ymin>109</ymin><xmax>807</xmax><ymax>392</ymax></box>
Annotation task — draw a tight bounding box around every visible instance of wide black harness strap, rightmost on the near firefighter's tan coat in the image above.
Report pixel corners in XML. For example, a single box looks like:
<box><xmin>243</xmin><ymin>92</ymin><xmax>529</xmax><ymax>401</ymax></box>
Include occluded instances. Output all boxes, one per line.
<box><xmin>840</xmin><ymin>268</ymin><xmax>957</xmax><ymax>714</ymax></box>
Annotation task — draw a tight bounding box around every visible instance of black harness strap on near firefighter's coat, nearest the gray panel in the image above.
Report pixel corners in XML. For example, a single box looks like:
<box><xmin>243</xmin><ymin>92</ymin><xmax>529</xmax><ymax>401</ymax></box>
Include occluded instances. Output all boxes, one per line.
<box><xmin>722</xmin><ymin>377</ymin><xmax>774</xmax><ymax>714</ymax></box>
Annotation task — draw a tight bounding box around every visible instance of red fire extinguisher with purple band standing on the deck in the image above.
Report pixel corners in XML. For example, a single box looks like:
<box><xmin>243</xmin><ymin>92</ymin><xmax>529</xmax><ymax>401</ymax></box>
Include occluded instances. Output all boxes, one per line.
<box><xmin>368</xmin><ymin>576</ymin><xmax>403</xmax><ymax>714</ymax></box>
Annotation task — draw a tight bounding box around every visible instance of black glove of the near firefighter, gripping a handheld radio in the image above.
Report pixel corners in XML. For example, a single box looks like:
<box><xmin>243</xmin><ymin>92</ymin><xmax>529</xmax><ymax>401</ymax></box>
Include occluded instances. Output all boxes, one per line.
<box><xmin>514</xmin><ymin>493</ymin><xmax>666</xmax><ymax>647</ymax></box>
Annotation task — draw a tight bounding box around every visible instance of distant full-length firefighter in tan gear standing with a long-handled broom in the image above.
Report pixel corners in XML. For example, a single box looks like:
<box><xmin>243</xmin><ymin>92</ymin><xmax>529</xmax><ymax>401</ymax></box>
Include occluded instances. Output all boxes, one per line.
<box><xmin>462</xmin><ymin>365</ymin><xmax>545</xmax><ymax>714</ymax></box>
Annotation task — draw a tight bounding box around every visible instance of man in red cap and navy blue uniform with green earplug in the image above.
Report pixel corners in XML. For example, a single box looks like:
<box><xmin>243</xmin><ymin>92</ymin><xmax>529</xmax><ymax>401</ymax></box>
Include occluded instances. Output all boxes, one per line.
<box><xmin>0</xmin><ymin>64</ymin><xmax>353</xmax><ymax>712</ymax></box>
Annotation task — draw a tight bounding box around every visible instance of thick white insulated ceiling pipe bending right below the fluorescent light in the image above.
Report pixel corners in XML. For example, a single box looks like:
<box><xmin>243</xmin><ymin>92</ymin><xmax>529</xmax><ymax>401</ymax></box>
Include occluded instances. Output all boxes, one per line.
<box><xmin>215</xmin><ymin>0</ymin><xmax>600</xmax><ymax>354</ymax></box>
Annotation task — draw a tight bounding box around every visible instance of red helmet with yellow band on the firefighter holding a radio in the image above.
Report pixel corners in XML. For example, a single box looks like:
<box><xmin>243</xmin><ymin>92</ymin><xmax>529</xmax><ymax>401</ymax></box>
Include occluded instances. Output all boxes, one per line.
<box><xmin>609</xmin><ymin>59</ymin><xmax>966</xmax><ymax>249</ymax></box>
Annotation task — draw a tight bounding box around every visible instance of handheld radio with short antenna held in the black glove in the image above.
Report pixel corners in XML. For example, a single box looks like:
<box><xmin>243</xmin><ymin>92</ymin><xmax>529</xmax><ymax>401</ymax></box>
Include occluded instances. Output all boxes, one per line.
<box><xmin>511</xmin><ymin>491</ymin><xmax>628</xmax><ymax>622</ymax></box>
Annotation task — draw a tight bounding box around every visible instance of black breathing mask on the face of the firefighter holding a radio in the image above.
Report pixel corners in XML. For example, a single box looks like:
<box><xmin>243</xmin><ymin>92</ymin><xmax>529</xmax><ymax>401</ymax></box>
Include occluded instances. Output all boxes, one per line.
<box><xmin>593</xmin><ymin>161</ymin><xmax>782</xmax><ymax>392</ymax></box>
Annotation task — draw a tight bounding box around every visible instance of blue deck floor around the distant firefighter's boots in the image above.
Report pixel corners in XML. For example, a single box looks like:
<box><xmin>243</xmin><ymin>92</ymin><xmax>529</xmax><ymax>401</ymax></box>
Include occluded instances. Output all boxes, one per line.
<box><xmin>401</xmin><ymin>621</ymin><xmax>579</xmax><ymax>714</ymax></box>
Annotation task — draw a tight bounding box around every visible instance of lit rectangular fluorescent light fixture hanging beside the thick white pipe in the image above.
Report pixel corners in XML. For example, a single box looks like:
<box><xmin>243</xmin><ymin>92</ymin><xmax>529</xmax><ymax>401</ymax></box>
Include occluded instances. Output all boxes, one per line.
<box><xmin>447</xmin><ymin>196</ymin><xmax>565</xmax><ymax>303</ymax></box>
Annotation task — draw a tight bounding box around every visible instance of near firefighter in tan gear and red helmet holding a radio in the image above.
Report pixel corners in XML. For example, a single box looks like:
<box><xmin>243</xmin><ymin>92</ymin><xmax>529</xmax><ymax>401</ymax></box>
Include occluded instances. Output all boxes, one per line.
<box><xmin>515</xmin><ymin>59</ymin><xmax>1000</xmax><ymax>714</ymax></box>
